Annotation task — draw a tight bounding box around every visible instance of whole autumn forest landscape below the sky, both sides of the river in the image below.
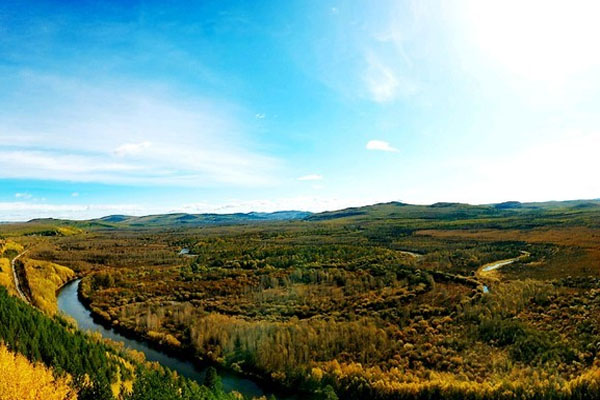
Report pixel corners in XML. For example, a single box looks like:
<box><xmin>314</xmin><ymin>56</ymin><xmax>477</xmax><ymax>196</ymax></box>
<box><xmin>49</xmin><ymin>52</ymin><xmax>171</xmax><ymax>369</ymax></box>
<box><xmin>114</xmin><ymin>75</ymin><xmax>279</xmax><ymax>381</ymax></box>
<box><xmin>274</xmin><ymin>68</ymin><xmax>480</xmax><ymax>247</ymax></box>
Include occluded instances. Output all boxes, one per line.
<box><xmin>0</xmin><ymin>201</ymin><xmax>600</xmax><ymax>400</ymax></box>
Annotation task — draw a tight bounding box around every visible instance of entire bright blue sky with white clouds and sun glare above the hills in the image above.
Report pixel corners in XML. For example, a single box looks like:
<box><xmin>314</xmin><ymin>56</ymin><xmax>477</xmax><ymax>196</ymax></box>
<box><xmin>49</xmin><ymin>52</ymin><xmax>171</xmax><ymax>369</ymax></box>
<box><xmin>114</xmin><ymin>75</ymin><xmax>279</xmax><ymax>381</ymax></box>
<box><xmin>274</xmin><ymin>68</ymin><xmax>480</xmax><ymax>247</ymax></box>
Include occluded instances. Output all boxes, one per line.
<box><xmin>0</xmin><ymin>0</ymin><xmax>600</xmax><ymax>221</ymax></box>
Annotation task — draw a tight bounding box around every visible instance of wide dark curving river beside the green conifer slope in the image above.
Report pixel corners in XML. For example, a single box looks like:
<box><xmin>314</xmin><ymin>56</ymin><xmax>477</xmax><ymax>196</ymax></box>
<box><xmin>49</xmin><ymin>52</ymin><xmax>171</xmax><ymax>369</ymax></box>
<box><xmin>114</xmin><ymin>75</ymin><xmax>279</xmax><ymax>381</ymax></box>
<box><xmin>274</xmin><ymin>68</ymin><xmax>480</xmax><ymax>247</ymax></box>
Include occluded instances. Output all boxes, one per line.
<box><xmin>58</xmin><ymin>279</ymin><xmax>298</xmax><ymax>400</ymax></box>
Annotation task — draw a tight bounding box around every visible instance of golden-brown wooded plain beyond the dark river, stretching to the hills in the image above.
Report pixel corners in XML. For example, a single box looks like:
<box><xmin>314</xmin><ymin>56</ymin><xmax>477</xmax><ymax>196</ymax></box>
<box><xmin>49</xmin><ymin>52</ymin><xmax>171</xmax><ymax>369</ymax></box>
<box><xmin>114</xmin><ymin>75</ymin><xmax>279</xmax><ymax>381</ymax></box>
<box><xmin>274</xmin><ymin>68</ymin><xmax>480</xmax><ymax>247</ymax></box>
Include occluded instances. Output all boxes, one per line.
<box><xmin>7</xmin><ymin>206</ymin><xmax>600</xmax><ymax>399</ymax></box>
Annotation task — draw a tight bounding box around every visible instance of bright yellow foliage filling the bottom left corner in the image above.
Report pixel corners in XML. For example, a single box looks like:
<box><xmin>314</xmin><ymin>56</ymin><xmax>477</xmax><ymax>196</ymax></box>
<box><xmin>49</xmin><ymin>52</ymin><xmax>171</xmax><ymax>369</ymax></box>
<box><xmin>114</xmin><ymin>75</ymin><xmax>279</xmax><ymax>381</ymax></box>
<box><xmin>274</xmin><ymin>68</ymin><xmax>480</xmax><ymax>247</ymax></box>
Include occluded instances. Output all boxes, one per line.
<box><xmin>0</xmin><ymin>345</ymin><xmax>77</xmax><ymax>400</ymax></box>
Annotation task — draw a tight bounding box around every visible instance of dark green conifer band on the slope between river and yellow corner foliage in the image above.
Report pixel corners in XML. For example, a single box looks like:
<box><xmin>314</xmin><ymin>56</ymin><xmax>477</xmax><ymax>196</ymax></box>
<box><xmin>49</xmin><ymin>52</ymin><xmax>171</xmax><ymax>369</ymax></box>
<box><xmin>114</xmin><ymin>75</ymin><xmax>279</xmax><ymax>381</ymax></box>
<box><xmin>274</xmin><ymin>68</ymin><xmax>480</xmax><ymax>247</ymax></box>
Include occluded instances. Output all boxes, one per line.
<box><xmin>0</xmin><ymin>287</ymin><xmax>250</xmax><ymax>400</ymax></box>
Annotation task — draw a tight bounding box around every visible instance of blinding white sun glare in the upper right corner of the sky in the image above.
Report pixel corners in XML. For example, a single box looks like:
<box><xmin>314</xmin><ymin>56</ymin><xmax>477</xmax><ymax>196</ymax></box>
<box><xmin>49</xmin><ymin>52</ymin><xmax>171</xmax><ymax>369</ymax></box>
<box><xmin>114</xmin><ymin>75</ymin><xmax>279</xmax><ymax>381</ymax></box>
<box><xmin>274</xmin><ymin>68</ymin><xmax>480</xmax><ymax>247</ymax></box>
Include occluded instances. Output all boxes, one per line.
<box><xmin>466</xmin><ymin>0</ymin><xmax>600</xmax><ymax>84</ymax></box>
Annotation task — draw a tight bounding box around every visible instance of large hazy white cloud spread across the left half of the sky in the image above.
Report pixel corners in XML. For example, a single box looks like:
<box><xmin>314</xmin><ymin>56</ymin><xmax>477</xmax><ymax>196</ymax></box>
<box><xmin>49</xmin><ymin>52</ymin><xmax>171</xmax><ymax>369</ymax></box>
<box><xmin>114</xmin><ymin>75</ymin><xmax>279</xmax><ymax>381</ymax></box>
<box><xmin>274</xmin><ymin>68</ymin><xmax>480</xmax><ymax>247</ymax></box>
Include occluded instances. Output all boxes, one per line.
<box><xmin>0</xmin><ymin>73</ymin><xmax>282</xmax><ymax>187</ymax></box>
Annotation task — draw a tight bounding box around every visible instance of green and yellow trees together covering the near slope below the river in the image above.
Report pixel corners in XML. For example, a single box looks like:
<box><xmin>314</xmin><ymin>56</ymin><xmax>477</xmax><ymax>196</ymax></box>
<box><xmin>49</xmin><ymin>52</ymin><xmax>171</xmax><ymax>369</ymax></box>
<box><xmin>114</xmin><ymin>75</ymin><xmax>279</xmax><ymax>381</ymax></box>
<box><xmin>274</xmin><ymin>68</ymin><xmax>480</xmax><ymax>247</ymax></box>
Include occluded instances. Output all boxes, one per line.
<box><xmin>0</xmin><ymin>287</ymin><xmax>244</xmax><ymax>400</ymax></box>
